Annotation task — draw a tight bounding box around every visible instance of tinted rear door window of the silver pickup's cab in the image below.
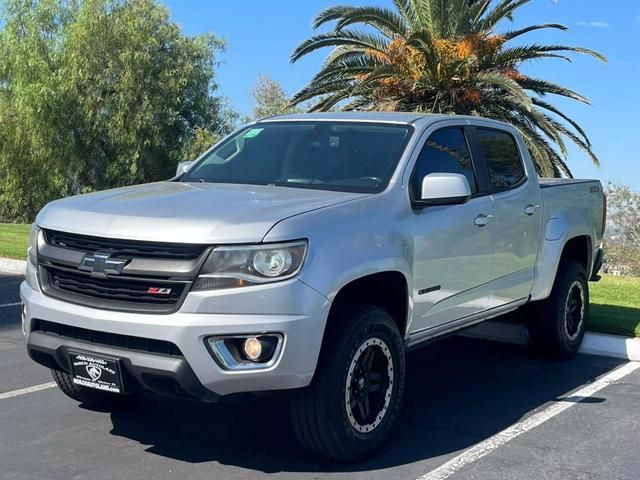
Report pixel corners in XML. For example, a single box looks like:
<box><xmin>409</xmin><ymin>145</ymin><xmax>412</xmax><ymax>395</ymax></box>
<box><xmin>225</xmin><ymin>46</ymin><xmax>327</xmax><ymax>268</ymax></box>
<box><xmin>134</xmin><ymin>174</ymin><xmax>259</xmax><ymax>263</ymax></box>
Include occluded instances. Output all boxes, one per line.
<box><xmin>476</xmin><ymin>127</ymin><xmax>525</xmax><ymax>192</ymax></box>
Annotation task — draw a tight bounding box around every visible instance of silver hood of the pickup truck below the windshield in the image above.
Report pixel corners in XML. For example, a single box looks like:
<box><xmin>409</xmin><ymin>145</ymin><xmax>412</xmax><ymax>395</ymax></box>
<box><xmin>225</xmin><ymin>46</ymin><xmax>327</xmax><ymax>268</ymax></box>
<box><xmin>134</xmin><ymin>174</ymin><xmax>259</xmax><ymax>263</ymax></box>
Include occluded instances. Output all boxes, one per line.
<box><xmin>36</xmin><ymin>182</ymin><xmax>365</xmax><ymax>243</ymax></box>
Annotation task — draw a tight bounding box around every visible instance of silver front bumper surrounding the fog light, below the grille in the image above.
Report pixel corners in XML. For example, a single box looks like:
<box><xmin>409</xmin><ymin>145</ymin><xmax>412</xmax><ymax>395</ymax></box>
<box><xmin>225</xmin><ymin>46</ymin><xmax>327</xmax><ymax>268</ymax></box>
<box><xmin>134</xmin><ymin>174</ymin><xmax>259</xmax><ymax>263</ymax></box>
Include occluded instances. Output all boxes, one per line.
<box><xmin>20</xmin><ymin>267</ymin><xmax>330</xmax><ymax>400</ymax></box>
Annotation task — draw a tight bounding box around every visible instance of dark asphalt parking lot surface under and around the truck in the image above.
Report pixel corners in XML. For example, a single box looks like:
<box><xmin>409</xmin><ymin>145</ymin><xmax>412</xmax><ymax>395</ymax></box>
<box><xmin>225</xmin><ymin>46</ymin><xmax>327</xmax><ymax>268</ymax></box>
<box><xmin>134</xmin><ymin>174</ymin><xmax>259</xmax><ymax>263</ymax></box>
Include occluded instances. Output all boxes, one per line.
<box><xmin>0</xmin><ymin>275</ymin><xmax>640</xmax><ymax>480</ymax></box>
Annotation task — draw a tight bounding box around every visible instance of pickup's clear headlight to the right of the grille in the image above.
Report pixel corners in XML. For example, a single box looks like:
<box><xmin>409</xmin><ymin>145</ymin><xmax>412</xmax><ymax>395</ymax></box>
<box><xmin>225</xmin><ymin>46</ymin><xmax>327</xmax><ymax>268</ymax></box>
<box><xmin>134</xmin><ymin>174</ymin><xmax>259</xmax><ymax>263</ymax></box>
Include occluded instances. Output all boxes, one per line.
<box><xmin>193</xmin><ymin>240</ymin><xmax>307</xmax><ymax>290</ymax></box>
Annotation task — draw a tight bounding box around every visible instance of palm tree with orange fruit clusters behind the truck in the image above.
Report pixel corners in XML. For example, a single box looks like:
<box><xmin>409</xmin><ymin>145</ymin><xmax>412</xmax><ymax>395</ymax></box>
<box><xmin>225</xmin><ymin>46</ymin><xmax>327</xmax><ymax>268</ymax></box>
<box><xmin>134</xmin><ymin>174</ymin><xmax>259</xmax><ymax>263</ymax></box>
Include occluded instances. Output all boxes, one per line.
<box><xmin>291</xmin><ymin>0</ymin><xmax>606</xmax><ymax>176</ymax></box>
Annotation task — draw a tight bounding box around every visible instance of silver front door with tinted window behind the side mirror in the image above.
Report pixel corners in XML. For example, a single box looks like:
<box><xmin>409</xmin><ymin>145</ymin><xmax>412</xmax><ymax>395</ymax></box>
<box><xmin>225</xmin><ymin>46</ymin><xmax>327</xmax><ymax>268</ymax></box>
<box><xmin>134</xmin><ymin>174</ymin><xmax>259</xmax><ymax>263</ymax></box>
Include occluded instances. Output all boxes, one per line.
<box><xmin>410</xmin><ymin>126</ymin><xmax>494</xmax><ymax>333</ymax></box>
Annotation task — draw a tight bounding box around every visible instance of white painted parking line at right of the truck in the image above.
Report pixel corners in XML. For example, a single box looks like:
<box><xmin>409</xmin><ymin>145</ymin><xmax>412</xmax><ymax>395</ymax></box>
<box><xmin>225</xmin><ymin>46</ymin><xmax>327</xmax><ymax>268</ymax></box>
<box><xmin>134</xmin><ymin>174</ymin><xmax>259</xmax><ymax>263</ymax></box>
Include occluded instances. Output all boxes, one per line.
<box><xmin>418</xmin><ymin>362</ymin><xmax>640</xmax><ymax>480</ymax></box>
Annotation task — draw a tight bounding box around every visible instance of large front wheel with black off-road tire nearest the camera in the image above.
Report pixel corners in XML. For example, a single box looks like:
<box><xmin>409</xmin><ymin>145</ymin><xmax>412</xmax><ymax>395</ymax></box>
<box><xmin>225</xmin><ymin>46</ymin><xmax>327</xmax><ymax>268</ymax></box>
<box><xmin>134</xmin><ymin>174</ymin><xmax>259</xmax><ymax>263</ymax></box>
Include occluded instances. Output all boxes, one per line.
<box><xmin>290</xmin><ymin>305</ymin><xmax>405</xmax><ymax>462</ymax></box>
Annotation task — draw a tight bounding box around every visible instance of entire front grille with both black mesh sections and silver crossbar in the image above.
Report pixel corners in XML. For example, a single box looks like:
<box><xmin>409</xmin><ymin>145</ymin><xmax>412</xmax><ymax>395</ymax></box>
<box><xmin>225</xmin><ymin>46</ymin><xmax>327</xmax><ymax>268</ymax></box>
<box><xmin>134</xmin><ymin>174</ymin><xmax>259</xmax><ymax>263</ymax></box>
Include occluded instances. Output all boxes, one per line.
<box><xmin>38</xmin><ymin>230</ymin><xmax>209</xmax><ymax>313</ymax></box>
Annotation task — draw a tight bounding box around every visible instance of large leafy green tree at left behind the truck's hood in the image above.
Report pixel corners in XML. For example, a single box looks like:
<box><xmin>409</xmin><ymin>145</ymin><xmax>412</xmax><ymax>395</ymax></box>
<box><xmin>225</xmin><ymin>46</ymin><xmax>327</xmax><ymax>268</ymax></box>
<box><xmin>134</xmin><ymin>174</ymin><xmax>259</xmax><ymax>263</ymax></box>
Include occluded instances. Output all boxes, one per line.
<box><xmin>0</xmin><ymin>0</ymin><xmax>235</xmax><ymax>220</ymax></box>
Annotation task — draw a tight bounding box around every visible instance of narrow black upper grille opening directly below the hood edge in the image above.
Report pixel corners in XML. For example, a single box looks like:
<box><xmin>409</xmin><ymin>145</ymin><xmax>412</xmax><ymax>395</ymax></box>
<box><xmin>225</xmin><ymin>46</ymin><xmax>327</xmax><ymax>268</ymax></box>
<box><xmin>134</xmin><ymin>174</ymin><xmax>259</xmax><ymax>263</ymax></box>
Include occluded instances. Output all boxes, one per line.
<box><xmin>44</xmin><ymin>230</ymin><xmax>206</xmax><ymax>260</ymax></box>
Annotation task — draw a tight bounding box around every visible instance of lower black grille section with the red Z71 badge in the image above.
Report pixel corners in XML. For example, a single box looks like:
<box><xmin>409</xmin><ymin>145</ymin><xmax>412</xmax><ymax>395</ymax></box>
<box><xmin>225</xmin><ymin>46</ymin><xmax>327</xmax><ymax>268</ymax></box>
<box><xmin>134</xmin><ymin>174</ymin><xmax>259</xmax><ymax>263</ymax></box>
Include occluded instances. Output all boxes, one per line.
<box><xmin>47</xmin><ymin>268</ymin><xmax>185</xmax><ymax>305</ymax></box>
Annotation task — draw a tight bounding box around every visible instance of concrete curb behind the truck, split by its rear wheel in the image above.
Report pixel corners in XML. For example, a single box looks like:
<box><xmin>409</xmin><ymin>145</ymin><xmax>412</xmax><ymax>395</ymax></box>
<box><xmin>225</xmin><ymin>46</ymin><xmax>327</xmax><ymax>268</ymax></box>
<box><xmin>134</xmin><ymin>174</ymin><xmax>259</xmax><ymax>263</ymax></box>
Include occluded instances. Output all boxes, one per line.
<box><xmin>459</xmin><ymin>321</ymin><xmax>640</xmax><ymax>362</ymax></box>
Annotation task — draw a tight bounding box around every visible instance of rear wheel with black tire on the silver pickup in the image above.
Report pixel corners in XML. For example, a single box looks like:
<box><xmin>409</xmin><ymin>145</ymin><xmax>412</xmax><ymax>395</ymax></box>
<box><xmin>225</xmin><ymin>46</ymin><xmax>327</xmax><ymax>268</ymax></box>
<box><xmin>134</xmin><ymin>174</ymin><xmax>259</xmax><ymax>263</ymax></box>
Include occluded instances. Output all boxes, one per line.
<box><xmin>529</xmin><ymin>260</ymin><xmax>589</xmax><ymax>358</ymax></box>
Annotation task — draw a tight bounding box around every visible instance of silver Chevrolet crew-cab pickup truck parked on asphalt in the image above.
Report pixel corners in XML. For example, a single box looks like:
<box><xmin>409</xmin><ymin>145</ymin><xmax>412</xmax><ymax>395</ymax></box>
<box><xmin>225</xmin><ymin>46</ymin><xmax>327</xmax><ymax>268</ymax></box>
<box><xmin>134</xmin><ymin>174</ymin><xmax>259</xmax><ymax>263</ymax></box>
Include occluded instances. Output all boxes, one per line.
<box><xmin>21</xmin><ymin>113</ymin><xmax>606</xmax><ymax>461</ymax></box>
